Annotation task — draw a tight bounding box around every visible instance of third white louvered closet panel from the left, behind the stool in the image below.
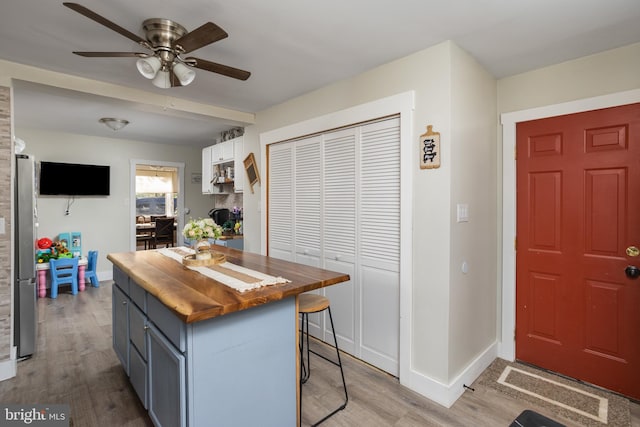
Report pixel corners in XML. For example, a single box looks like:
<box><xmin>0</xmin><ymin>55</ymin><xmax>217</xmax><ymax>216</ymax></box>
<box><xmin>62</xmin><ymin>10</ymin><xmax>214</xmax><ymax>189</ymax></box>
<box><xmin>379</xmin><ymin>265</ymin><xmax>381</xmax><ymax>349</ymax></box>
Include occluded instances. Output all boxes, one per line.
<box><xmin>322</xmin><ymin>128</ymin><xmax>359</xmax><ymax>354</ymax></box>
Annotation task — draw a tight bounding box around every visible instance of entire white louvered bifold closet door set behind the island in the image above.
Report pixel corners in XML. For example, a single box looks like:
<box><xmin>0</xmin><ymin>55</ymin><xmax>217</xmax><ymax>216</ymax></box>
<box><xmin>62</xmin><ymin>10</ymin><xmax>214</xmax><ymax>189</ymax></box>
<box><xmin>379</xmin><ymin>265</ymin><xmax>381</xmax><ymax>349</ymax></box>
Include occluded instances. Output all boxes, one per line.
<box><xmin>267</xmin><ymin>118</ymin><xmax>400</xmax><ymax>375</ymax></box>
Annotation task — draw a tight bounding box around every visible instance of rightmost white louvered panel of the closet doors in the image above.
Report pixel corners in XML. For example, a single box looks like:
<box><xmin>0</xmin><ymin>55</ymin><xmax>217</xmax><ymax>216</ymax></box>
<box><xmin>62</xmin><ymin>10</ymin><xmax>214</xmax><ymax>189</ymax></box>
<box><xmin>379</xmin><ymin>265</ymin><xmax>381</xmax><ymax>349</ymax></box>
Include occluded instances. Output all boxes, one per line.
<box><xmin>357</xmin><ymin>119</ymin><xmax>400</xmax><ymax>375</ymax></box>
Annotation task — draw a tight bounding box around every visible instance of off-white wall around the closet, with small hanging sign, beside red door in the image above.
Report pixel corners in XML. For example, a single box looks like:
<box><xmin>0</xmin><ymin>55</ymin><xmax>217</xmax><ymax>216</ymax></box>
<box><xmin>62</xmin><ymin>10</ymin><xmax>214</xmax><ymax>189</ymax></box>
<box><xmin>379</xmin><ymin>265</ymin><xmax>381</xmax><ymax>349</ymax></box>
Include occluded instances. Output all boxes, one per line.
<box><xmin>244</xmin><ymin>42</ymin><xmax>497</xmax><ymax>405</ymax></box>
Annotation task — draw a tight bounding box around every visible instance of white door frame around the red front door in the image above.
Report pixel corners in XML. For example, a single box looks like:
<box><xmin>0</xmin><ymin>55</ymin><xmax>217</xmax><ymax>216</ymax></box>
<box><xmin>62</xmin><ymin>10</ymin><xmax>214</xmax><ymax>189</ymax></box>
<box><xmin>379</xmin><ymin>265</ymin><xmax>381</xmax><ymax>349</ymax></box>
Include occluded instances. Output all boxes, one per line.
<box><xmin>498</xmin><ymin>89</ymin><xmax>640</xmax><ymax>361</ymax></box>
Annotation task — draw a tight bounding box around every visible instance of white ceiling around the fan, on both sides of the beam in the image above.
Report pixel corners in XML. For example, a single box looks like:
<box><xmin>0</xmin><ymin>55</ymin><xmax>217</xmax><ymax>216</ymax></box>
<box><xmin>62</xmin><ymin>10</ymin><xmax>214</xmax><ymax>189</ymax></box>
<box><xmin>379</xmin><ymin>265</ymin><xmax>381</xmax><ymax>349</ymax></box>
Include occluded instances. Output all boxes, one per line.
<box><xmin>0</xmin><ymin>0</ymin><xmax>640</xmax><ymax>146</ymax></box>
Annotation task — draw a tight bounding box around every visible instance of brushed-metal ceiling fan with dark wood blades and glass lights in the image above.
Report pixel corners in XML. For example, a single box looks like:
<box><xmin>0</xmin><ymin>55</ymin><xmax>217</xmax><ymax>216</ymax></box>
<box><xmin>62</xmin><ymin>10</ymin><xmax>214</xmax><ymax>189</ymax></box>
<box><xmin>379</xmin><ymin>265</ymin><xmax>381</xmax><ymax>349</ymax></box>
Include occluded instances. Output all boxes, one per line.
<box><xmin>62</xmin><ymin>3</ymin><xmax>251</xmax><ymax>89</ymax></box>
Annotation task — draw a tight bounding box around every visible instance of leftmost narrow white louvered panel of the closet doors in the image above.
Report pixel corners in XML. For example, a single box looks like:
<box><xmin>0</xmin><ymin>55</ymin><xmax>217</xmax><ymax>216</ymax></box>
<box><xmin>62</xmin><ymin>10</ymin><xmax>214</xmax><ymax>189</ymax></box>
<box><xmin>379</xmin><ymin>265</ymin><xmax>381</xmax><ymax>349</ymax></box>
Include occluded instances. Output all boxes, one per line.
<box><xmin>267</xmin><ymin>143</ymin><xmax>294</xmax><ymax>261</ymax></box>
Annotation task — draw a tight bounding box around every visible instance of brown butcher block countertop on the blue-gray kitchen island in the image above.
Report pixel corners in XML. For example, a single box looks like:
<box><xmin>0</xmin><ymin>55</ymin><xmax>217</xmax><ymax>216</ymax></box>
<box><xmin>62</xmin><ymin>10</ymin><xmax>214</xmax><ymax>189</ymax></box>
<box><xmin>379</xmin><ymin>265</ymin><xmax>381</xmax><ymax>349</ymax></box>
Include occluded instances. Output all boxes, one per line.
<box><xmin>107</xmin><ymin>245</ymin><xmax>349</xmax><ymax>323</ymax></box>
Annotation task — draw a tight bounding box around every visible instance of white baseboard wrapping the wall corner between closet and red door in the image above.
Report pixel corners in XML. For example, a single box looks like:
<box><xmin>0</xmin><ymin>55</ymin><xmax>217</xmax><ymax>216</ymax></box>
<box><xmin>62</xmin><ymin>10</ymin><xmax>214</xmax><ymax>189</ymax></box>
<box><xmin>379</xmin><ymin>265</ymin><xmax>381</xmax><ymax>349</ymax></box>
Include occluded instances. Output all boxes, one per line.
<box><xmin>400</xmin><ymin>343</ymin><xmax>498</xmax><ymax>408</ymax></box>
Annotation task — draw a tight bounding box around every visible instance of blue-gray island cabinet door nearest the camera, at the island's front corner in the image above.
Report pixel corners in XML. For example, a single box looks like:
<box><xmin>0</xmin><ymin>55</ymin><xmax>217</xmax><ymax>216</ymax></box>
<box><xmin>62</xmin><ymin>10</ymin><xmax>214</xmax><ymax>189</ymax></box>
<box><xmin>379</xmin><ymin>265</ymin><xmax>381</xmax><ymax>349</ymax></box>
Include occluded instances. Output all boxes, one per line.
<box><xmin>147</xmin><ymin>323</ymin><xmax>187</xmax><ymax>427</ymax></box>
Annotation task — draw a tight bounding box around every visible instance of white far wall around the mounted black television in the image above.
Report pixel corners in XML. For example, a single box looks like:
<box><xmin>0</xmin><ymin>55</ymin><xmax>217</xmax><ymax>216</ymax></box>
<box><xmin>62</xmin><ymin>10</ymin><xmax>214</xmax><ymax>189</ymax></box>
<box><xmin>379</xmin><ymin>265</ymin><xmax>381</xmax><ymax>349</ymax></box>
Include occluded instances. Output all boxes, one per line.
<box><xmin>16</xmin><ymin>128</ymin><xmax>212</xmax><ymax>279</ymax></box>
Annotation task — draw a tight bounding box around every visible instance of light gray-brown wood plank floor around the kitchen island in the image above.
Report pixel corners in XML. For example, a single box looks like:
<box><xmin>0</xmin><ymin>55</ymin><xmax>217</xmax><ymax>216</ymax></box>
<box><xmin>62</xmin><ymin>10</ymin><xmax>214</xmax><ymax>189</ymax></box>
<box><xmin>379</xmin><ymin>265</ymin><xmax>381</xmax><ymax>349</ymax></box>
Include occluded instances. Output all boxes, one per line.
<box><xmin>0</xmin><ymin>282</ymin><xmax>640</xmax><ymax>427</ymax></box>
